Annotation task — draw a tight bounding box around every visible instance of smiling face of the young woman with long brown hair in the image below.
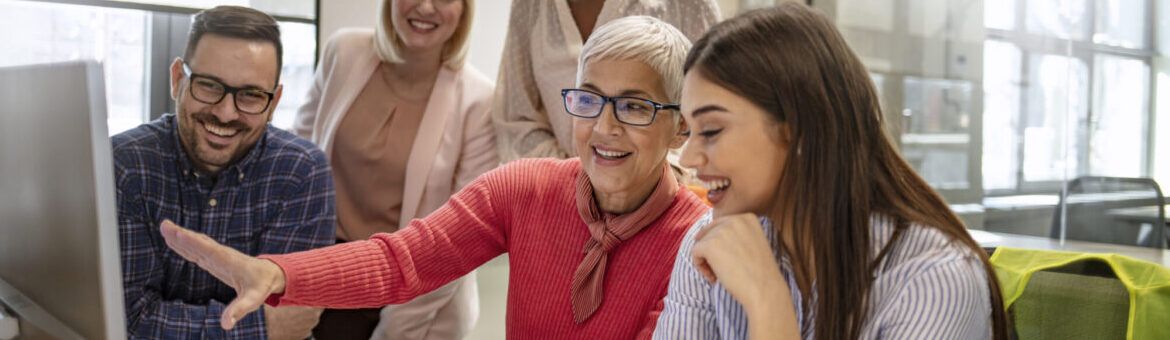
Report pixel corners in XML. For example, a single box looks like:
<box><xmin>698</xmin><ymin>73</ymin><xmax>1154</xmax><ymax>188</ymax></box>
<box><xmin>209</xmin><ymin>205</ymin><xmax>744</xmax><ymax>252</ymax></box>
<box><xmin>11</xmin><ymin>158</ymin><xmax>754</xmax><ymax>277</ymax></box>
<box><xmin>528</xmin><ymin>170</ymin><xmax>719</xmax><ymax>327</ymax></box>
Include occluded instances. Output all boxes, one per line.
<box><xmin>681</xmin><ymin>70</ymin><xmax>789</xmax><ymax>216</ymax></box>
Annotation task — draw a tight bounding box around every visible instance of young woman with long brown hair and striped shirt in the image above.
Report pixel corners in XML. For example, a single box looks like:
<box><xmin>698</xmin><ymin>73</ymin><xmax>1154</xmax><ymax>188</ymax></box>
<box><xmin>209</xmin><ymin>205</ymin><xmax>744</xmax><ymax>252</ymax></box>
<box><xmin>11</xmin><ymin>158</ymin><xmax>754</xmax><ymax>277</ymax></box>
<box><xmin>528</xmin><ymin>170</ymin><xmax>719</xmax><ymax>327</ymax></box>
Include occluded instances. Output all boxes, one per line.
<box><xmin>655</xmin><ymin>4</ymin><xmax>1006</xmax><ymax>339</ymax></box>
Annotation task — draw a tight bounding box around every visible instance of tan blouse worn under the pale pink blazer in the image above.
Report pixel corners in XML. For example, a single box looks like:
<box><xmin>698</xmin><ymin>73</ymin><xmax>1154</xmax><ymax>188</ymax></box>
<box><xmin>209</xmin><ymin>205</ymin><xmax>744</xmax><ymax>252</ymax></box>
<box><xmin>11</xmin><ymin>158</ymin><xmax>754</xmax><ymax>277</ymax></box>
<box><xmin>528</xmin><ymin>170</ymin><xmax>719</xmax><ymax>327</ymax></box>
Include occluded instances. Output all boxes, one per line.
<box><xmin>331</xmin><ymin>63</ymin><xmax>424</xmax><ymax>241</ymax></box>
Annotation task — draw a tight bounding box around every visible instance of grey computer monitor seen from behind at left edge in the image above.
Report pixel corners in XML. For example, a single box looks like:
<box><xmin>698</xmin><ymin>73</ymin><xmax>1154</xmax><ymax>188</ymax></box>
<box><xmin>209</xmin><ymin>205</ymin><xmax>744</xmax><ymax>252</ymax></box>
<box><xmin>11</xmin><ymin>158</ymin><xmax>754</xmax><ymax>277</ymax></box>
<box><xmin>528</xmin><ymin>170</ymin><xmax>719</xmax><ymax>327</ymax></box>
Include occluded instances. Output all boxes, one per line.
<box><xmin>0</xmin><ymin>62</ymin><xmax>126</xmax><ymax>339</ymax></box>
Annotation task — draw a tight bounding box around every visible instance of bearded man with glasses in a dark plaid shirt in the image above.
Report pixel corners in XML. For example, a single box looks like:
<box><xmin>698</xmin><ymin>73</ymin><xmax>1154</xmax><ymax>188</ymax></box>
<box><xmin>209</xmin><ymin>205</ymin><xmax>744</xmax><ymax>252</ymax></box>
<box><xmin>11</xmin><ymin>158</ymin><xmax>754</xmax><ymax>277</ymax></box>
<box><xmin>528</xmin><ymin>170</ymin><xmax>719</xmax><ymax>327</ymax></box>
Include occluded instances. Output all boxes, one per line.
<box><xmin>112</xmin><ymin>6</ymin><xmax>335</xmax><ymax>339</ymax></box>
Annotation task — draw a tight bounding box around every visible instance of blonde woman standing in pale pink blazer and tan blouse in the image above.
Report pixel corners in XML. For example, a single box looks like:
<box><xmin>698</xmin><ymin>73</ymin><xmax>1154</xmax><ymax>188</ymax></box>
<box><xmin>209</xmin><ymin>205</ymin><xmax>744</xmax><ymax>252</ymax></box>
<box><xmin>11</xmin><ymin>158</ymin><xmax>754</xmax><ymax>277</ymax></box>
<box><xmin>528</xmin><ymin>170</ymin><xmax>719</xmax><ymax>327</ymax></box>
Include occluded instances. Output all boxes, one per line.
<box><xmin>295</xmin><ymin>0</ymin><xmax>497</xmax><ymax>339</ymax></box>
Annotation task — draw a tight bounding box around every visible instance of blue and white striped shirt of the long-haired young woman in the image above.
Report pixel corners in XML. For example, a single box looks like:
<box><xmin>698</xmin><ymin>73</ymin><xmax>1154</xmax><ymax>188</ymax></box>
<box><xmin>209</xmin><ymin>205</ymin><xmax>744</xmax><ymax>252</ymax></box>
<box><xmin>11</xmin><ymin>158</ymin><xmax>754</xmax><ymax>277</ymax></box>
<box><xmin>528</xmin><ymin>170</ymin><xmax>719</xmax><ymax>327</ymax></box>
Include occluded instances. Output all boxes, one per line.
<box><xmin>654</xmin><ymin>213</ymin><xmax>991</xmax><ymax>339</ymax></box>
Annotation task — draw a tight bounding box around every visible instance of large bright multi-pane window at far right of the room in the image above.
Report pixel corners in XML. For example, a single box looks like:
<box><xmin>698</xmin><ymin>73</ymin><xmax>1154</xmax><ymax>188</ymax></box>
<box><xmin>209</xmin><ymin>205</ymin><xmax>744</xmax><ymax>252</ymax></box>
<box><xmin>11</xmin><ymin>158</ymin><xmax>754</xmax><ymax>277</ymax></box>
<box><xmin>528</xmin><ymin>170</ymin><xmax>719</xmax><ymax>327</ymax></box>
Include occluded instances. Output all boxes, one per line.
<box><xmin>983</xmin><ymin>0</ymin><xmax>1154</xmax><ymax>194</ymax></box>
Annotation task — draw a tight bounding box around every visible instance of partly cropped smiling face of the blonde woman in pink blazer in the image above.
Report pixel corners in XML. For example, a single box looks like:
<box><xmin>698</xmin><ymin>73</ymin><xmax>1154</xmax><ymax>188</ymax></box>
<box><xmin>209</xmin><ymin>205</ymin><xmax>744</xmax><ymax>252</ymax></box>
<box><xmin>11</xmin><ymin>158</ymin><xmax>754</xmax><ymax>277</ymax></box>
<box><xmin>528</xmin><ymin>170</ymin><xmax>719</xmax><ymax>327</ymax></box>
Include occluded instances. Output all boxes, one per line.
<box><xmin>387</xmin><ymin>0</ymin><xmax>463</xmax><ymax>55</ymax></box>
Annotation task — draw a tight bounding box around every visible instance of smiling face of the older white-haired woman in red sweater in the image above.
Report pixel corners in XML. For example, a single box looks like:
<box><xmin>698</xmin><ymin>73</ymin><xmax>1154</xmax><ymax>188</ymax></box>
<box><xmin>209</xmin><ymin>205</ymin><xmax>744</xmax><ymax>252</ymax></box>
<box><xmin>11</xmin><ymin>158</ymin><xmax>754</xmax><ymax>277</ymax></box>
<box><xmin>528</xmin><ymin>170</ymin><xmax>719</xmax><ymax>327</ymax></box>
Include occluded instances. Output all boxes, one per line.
<box><xmin>573</xmin><ymin>60</ymin><xmax>684</xmax><ymax>213</ymax></box>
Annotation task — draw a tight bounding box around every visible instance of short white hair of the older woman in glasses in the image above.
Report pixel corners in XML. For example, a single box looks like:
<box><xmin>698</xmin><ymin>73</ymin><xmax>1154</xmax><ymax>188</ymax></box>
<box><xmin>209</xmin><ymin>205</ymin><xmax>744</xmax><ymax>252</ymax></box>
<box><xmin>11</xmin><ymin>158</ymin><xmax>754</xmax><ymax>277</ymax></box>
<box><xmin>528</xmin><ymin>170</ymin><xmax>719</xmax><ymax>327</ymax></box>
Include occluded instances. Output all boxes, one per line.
<box><xmin>577</xmin><ymin>15</ymin><xmax>690</xmax><ymax>104</ymax></box>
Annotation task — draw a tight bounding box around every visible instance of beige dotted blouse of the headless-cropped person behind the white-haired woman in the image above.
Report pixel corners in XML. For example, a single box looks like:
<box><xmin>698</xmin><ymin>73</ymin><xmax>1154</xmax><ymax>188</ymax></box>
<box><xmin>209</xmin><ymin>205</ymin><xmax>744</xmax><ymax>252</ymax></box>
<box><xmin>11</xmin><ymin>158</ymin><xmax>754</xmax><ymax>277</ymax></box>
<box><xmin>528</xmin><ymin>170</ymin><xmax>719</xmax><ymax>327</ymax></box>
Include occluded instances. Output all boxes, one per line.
<box><xmin>491</xmin><ymin>0</ymin><xmax>720</xmax><ymax>162</ymax></box>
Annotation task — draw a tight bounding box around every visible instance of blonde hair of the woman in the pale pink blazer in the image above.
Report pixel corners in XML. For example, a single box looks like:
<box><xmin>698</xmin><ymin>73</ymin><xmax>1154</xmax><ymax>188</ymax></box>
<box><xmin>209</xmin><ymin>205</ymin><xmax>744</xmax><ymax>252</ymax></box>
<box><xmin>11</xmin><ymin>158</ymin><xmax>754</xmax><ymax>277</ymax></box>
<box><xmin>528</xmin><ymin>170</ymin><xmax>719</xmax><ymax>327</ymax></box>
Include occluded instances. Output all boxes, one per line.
<box><xmin>373</xmin><ymin>0</ymin><xmax>475</xmax><ymax>70</ymax></box>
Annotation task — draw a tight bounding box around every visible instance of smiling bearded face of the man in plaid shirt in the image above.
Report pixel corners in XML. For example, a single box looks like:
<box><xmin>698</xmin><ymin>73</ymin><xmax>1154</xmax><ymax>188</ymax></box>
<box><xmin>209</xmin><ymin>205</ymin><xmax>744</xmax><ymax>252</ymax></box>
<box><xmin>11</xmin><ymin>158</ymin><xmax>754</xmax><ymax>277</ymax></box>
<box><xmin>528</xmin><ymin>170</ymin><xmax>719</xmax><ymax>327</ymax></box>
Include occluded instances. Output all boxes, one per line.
<box><xmin>171</xmin><ymin>34</ymin><xmax>282</xmax><ymax>174</ymax></box>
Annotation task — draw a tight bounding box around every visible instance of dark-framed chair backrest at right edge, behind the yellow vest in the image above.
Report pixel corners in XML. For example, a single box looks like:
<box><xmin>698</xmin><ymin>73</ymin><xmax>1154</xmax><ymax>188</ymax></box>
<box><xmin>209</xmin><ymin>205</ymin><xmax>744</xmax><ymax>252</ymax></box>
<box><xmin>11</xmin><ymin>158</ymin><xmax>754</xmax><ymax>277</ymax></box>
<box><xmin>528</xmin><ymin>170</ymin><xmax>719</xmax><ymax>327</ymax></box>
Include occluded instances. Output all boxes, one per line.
<box><xmin>1049</xmin><ymin>176</ymin><xmax>1166</xmax><ymax>249</ymax></box>
